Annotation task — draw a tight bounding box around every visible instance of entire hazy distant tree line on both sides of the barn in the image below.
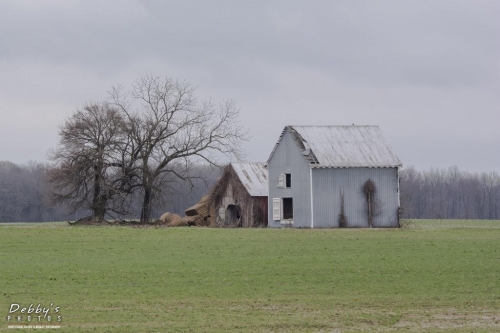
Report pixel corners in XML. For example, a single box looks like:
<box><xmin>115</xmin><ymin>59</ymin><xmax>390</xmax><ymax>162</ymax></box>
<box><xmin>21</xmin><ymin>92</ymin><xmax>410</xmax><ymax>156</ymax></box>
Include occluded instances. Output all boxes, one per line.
<box><xmin>0</xmin><ymin>161</ymin><xmax>500</xmax><ymax>222</ymax></box>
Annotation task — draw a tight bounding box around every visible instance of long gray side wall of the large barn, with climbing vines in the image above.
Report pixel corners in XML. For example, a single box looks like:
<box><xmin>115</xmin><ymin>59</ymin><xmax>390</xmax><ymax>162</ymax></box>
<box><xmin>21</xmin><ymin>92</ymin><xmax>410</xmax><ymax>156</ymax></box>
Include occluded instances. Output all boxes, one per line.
<box><xmin>312</xmin><ymin>168</ymin><xmax>399</xmax><ymax>228</ymax></box>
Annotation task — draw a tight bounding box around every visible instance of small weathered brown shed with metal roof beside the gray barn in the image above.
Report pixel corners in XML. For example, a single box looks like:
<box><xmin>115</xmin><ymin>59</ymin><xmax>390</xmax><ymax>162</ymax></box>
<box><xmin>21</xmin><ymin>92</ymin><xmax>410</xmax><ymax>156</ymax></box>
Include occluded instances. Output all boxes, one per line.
<box><xmin>207</xmin><ymin>163</ymin><xmax>268</xmax><ymax>227</ymax></box>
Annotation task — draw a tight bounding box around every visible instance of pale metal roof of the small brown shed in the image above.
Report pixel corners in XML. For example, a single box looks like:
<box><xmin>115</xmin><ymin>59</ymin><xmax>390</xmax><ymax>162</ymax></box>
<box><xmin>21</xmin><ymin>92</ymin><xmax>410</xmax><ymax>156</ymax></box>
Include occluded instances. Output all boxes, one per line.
<box><xmin>231</xmin><ymin>162</ymin><xmax>269</xmax><ymax>197</ymax></box>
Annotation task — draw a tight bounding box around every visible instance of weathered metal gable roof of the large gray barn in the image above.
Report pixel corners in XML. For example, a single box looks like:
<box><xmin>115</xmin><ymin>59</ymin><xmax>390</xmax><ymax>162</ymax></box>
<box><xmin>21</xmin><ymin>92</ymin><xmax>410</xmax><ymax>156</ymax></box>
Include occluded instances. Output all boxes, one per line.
<box><xmin>267</xmin><ymin>125</ymin><xmax>402</xmax><ymax>168</ymax></box>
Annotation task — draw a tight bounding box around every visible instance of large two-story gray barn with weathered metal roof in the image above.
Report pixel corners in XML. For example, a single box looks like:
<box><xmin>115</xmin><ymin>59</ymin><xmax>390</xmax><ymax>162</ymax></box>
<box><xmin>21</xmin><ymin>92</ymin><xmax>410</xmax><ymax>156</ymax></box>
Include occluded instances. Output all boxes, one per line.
<box><xmin>267</xmin><ymin>125</ymin><xmax>402</xmax><ymax>228</ymax></box>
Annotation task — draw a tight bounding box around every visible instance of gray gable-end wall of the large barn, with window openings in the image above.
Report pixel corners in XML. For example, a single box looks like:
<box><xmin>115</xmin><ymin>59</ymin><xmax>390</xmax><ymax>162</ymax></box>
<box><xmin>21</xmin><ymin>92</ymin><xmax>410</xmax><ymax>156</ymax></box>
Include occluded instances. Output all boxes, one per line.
<box><xmin>268</xmin><ymin>130</ymin><xmax>311</xmax><ymax>228</ymax></box>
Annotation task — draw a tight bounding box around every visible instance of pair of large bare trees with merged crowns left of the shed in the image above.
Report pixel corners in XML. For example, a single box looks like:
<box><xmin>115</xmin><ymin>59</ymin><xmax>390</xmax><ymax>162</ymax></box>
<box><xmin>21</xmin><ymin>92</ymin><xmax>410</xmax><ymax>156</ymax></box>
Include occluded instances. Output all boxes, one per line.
<box><xmin>47</xmin><ymin>76</ymin><xmax>246</xmax><ymax>222</ymax></box>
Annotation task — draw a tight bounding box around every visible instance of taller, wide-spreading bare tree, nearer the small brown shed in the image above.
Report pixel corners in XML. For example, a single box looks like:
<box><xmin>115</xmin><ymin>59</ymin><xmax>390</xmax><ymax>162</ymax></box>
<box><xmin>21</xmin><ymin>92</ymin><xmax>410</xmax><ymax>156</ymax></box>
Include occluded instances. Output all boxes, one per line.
<box><xmin>110</xmin><ymin>76</ymin><xmax>246</xmax><ymax>222</ymax></box>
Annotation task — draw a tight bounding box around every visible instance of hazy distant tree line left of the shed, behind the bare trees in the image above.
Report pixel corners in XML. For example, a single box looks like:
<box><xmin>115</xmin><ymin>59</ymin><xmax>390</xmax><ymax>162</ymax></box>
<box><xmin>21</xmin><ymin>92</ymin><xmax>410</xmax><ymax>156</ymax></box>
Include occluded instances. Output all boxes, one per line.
<box><xmin>0</xmin><ymin>161</ymin><xmax>220</xmax><ymax>223</ymax></box>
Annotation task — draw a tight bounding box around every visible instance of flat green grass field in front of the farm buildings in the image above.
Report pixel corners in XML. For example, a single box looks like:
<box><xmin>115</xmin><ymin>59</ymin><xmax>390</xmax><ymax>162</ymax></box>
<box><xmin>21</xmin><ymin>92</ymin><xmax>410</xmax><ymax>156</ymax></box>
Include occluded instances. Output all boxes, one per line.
<box><xmin>0</xmin><ymin>220</ymin><xmax>500</xmax><ymax>332</ymax></box>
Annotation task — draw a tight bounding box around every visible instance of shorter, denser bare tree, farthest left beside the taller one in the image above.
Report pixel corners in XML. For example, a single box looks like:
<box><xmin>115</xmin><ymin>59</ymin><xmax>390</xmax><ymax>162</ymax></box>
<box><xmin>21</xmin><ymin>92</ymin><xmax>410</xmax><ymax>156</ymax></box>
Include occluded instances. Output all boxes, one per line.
<box><xmin>47</xmin><ymin>103</ymin><xmax>131</xmax><ymax>219</ymax></box>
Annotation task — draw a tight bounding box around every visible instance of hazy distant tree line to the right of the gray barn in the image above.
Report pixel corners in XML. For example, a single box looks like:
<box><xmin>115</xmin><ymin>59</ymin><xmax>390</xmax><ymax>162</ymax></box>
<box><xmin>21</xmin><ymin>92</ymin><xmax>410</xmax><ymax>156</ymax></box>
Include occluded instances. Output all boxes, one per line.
<box><xmin>400</xmin><ymin>166</ymin><xmax>500</xmax><ymax>219</ymax></box>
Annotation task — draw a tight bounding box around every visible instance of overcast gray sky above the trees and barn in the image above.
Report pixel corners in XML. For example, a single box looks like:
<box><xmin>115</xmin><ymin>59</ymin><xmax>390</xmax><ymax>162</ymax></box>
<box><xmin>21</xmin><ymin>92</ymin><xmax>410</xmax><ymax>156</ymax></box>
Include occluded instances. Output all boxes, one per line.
<box><xmin>0</xmin><ymin>0</ymin><xmax>500</xmax><ymax>172</ymax></box>
